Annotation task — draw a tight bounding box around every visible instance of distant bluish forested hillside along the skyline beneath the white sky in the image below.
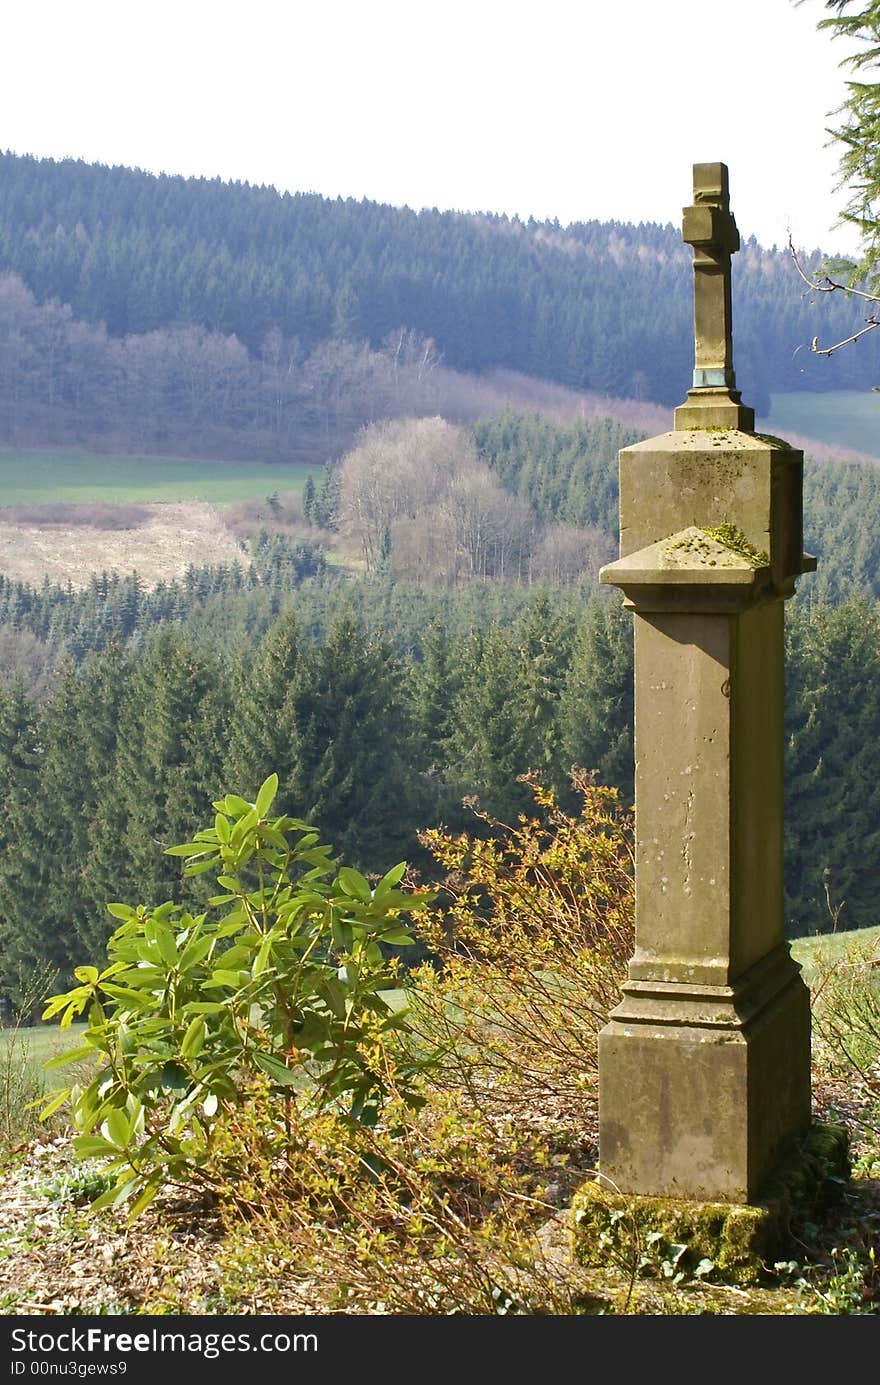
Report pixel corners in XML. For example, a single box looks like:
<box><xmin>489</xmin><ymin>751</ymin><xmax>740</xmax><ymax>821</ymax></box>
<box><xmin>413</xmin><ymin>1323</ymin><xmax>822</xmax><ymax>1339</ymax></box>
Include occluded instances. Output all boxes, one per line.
<box><xmin>0</xmin><ymin>154</ymin><xmax>880</xmax><ymax>446</ymax></box>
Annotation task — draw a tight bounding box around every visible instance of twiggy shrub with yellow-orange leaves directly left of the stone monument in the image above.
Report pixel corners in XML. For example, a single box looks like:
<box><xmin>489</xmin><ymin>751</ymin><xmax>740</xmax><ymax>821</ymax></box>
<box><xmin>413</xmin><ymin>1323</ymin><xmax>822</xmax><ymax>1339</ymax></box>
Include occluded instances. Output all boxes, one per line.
<box><xmin>410</xmin><ymin>770</ymin><xmax>635</xmax><ymax>1122</ymax></box>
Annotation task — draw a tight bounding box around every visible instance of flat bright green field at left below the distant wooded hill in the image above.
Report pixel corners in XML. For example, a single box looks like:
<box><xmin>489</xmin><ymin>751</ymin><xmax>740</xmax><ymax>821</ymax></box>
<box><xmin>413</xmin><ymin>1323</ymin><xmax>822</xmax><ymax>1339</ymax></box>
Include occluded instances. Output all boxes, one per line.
<box><xmin>0</xmin><ymin>449</ymin><xmax>320</xmax><ymax>506</ymax></box>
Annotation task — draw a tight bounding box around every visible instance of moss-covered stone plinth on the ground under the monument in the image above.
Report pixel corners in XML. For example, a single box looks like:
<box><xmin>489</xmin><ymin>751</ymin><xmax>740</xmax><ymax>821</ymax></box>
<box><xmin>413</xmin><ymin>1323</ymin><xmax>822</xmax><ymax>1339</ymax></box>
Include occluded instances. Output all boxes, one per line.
<box><xmin>571</xmin><ymin>1125</ymin><xmax>850</xmax><ymax>1285</ymax></box>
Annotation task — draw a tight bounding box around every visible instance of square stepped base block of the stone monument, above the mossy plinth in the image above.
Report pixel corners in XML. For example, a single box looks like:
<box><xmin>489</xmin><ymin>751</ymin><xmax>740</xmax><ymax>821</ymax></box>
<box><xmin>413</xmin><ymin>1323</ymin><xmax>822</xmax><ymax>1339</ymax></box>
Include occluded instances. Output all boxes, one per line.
<box><xmin>599</xmin><ymin>945</ymin><xmax>811</xmax><ymax>1204</ymax></box>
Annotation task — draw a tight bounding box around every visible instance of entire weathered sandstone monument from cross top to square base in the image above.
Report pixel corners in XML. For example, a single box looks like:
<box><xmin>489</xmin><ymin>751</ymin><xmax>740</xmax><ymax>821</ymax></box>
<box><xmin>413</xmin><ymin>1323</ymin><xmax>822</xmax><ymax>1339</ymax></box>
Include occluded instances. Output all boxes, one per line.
<box><xmin>579</xmin><ymin>163</ymin><xmax>831</xmax><ymax>1222</ymax></box>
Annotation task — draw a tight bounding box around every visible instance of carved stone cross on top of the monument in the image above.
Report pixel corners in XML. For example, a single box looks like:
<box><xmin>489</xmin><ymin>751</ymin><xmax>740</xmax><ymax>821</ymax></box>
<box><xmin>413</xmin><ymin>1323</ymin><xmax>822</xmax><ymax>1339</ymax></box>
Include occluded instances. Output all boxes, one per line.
<box><xmin>675</xmin><ymin>163</ymin><xmax>755</xmax><ymax>431</ymax></box>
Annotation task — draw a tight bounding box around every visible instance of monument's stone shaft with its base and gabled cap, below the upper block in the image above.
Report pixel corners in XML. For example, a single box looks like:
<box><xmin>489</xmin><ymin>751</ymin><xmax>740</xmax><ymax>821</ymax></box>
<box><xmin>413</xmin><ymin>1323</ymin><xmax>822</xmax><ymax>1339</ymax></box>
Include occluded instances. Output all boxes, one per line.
<box><xmin>599</xmin><ymin>525</ymin><xmax>811</xmax><ymax>1202</ymax></box>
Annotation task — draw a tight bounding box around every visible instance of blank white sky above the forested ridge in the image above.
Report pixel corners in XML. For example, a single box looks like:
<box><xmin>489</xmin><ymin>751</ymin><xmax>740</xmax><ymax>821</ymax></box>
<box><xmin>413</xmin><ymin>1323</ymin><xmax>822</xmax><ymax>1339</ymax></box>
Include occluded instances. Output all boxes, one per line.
<box><xmin>0</xmin><ymin>0</ymin><xmax>870</xmax><ymax>252</ymax></box>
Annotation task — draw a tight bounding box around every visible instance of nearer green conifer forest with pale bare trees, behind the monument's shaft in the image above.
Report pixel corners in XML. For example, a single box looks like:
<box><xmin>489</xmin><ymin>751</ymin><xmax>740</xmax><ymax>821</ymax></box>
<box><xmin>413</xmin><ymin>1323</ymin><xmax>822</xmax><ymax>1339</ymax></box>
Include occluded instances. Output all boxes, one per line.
<box><xmin>0</xmin><ymin>414</ymin><xmax>880</xmax><ymax>994</ymax></box>
